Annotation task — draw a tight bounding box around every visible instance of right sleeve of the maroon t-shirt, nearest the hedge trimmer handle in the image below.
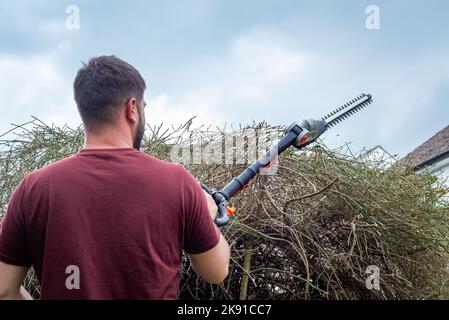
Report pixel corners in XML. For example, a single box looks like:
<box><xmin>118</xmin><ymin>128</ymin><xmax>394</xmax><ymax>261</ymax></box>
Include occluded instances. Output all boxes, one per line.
<box><xmin>179</xmin><ymin>168</ymin><xmax>221</xmax><ymax>254</ymax></box>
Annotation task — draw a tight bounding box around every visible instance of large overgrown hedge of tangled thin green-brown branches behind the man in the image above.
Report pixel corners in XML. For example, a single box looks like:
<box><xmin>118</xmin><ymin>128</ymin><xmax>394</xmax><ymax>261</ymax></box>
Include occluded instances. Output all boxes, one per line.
<box><xmin>0</xmin><ymin>119</ymin><xmax>449</xmax><ymax>299</ymax></box>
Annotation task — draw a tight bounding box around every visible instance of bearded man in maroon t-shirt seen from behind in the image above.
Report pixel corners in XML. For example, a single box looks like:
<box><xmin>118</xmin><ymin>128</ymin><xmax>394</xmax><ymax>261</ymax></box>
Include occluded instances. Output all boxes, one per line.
<box><xmin>0</xmin><ymin>56</ymin><xmax>229</xmax><ymax>299</ymax></box>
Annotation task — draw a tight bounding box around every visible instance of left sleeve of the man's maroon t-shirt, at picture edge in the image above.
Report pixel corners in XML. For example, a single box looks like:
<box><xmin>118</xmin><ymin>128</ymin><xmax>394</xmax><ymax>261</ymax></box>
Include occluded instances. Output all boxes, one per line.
<box><xmin>0</xmin><ymin>178</ymin><xmax>31</xmax><ymax>266</ymax></box>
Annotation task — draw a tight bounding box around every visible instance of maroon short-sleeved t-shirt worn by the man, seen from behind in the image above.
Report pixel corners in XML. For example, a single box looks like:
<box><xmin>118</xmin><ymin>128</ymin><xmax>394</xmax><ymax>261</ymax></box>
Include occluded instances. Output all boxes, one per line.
<box><xmin>0</xmin><ymin>148</ymin><xmax>220</xmax><ymax>299</ymax></box>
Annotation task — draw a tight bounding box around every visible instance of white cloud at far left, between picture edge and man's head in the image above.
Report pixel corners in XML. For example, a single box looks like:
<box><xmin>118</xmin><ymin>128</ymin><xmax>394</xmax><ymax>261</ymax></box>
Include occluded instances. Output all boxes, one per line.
<box><xmin>0</xmin><ymin>51</ymin><xmax>80</xmax><ymax>132</ymax></box>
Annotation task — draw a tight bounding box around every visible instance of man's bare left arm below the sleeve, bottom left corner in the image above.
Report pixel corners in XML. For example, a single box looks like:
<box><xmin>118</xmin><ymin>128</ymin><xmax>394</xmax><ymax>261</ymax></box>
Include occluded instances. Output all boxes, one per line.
<box><xmin>0</xmin><ymin>261</ymin><xmax>33</xmax><ymax>300</ymax></box>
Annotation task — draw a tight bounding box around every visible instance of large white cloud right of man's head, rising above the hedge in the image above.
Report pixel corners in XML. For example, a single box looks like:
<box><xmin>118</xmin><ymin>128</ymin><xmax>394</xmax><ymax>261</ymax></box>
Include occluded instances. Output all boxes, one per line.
<box><xmin>147</xmin><ymin>30</ymin><xmax>311</xmax><ymax>125</ymax></box>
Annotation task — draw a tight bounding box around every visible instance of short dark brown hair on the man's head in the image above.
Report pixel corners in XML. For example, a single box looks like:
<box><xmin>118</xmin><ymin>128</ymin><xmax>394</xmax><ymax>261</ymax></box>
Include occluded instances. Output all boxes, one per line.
<box><xmin>73</xmin><ymin>56</ymin><xmax>146</xmax><ymax>132</ymax></box>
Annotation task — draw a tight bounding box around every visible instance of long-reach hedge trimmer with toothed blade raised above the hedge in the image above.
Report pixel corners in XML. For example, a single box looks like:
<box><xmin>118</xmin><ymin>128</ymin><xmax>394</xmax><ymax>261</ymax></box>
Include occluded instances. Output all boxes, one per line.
<box><xmin>200</xmin><ymin>94</ymin><xmax>372</xmax><ymax>227</ymax></box>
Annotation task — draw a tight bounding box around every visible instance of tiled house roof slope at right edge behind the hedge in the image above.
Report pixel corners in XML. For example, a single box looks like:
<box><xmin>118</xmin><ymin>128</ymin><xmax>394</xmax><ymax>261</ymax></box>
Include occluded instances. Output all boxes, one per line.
<box><xmin>400</xmin><ymin>126</ymin><xmax>449</xmax><ymax>167</ymax></box>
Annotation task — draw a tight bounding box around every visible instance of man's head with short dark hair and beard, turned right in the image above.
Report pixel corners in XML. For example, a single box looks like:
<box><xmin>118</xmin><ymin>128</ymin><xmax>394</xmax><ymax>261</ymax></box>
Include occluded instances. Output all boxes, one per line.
<box><xmin>73</xmin><ymin>56</ymin><xmax>146</xmax><ymax>149</ymax></box>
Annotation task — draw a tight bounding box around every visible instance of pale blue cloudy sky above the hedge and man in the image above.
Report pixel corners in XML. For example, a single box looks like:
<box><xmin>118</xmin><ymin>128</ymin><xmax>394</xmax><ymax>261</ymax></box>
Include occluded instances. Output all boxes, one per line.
<box><xmin>0</xmin><ymin>0</ymin><xmax>449</xmax><ymax>156</ymax></box>
